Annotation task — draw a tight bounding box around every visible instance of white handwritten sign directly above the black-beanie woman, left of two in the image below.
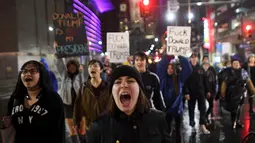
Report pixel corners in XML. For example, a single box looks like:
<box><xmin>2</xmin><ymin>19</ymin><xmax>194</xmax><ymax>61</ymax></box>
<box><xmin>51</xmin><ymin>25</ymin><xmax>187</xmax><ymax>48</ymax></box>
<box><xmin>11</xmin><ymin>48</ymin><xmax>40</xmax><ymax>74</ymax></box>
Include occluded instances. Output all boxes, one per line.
<box><xmin>107</xmin><ymin>32</ymin><xmax>129</xmax><ymax>63</ymax></box>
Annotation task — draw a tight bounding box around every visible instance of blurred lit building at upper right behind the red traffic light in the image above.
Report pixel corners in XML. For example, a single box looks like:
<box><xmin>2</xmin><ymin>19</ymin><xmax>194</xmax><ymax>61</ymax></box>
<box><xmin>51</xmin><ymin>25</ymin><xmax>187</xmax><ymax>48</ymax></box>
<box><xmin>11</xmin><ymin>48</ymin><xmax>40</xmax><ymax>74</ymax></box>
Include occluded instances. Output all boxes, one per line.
<box><xmin>214</xmin><ymin>0</ymin><xmax>255</xmax><ymax>61</ymax></box>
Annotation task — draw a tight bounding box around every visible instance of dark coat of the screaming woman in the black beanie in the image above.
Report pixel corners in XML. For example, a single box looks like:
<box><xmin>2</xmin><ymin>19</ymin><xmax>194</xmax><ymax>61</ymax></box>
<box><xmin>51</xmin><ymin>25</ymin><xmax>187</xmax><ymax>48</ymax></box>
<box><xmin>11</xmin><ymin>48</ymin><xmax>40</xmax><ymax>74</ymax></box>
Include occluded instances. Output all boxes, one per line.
<box><xmin>86</xmin><ymin>109</ymin><xmax>171</xmax><ymax>143</ymax></box>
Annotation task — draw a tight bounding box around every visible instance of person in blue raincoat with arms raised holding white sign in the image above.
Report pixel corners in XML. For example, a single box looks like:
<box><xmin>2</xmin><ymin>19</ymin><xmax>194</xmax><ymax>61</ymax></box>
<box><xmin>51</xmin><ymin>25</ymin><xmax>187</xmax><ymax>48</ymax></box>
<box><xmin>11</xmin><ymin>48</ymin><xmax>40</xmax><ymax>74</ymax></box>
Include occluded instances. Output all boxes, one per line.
<box><xmin>158</xmin><ymin>56</ymin><xmax>192</xmax><ymax>143</ymax></box>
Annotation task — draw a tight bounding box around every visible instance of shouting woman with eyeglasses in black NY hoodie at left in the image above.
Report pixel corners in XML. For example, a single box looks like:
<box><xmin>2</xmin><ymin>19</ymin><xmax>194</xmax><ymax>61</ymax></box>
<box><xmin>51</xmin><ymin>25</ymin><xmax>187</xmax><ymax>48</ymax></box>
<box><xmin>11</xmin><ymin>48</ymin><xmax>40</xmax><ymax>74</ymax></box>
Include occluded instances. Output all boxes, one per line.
<box><xmin>1</xmin><ymin>61</ymin><xmax>65</xmax><ymax>143</ymax></box>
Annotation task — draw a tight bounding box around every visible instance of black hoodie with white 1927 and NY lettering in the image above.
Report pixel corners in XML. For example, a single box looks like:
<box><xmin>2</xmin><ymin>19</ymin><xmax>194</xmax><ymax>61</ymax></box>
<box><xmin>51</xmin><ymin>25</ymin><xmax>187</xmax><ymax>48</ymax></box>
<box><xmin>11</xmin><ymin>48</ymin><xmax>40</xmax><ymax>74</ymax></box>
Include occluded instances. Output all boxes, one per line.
<box><xmin>8</xmin><ymin>90</ymin><xmax>65</xmax><ymax>143</ymax></box>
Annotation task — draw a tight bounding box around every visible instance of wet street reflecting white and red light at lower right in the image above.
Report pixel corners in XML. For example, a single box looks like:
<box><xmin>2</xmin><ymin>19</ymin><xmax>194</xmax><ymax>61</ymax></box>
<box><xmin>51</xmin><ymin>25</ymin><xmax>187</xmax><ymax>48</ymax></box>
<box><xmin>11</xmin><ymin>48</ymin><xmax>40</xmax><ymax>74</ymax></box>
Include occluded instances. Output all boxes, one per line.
<box><xmin>173</xmin><ymin>96</ymin><xmax>255</xmax><ymax>143</ymax></box>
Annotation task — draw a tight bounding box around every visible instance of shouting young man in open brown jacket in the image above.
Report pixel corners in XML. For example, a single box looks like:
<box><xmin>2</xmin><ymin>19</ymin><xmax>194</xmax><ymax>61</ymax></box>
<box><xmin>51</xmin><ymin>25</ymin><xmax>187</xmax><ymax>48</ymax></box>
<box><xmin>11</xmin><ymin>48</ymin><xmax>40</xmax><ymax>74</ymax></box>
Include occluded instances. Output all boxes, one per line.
<box><xmin>73</xmin><ymin>60</ymin><xmax>110</xmax><ymax>141</ymax></box>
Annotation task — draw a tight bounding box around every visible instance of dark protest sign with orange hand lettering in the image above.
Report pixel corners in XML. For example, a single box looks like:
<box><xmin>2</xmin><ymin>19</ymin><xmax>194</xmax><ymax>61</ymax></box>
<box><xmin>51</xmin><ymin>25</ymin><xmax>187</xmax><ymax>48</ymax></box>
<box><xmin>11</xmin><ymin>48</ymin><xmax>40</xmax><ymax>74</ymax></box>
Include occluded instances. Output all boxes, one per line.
<box><xmin>52</xmin><ymin>12</ymin><xmax>89</xmax><ymax>57</ymax></box>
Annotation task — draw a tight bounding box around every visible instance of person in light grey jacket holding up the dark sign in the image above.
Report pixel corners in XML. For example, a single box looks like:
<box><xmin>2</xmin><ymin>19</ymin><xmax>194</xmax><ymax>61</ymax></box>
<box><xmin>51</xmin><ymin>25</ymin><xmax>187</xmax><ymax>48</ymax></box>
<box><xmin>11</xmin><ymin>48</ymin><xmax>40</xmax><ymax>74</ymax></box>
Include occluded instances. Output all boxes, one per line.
<box><xmin>57</xmin><ymin>59</ymin><xmax>84</xmax><ymax>143</ymax></box>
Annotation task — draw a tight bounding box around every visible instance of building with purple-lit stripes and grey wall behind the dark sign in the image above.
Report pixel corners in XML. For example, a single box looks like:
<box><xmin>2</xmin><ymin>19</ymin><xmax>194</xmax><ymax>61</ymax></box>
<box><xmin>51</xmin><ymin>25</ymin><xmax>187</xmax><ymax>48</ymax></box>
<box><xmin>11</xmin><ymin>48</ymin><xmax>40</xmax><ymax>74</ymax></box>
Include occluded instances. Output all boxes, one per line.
<box><xmin>0</xmin><ymin>0</ymin><xmax>113</xmax><ymax>94</ymax></box>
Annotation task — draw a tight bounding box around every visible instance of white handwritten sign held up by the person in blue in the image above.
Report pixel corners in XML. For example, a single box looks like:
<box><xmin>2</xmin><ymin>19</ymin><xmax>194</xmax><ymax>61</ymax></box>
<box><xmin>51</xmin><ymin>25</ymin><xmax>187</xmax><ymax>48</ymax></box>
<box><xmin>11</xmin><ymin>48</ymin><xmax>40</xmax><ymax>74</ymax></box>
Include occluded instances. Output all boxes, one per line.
<box><xmin>167</xmin><ymin>26</ymin><xmax>191</xmax><ymax>56</ymax></box>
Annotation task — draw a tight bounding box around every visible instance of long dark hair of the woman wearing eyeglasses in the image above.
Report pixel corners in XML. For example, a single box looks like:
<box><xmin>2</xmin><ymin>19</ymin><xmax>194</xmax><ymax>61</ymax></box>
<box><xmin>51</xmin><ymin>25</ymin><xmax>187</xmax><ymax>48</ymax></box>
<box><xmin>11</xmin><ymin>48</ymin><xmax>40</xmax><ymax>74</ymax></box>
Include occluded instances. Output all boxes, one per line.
<box><xmin>12</xmin><ymin>60</ymin><xmax>53</xmax><ymax>99</ymax></box>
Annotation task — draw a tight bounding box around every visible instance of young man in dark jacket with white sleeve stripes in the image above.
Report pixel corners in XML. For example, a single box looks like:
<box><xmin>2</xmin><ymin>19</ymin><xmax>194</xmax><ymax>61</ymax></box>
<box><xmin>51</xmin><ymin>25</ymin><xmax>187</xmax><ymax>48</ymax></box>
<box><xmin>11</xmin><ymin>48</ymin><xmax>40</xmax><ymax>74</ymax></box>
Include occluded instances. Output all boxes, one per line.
<box><xmin>134</xmin><ymin>52</ymin><xmax>165</xmax><ymax>111</ymax></box>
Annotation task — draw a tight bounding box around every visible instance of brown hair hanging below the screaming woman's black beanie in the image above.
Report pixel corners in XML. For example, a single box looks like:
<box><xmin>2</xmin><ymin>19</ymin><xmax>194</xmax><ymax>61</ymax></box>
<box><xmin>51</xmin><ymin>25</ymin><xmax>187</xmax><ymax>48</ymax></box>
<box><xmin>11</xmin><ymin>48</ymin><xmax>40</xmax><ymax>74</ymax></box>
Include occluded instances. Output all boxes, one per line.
<box><xmin>108</xmin><ymin>88</ymin><xmax>150</xmax><ymax>114</ymax></box>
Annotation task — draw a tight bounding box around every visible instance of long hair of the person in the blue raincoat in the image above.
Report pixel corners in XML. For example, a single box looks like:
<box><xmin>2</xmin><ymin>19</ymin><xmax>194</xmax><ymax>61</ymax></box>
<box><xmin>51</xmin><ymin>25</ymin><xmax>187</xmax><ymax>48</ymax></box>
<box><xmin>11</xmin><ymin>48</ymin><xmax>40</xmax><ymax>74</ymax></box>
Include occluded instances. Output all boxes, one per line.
<box><xmin>166</xmin><ymin>63</ymin><xmax>180</xmax><ymax>96</ymax></box>
